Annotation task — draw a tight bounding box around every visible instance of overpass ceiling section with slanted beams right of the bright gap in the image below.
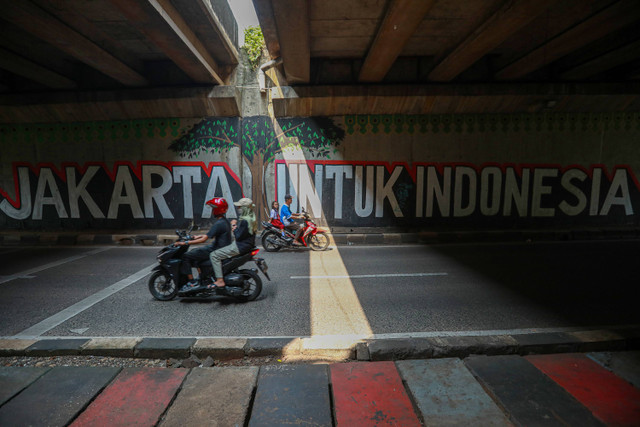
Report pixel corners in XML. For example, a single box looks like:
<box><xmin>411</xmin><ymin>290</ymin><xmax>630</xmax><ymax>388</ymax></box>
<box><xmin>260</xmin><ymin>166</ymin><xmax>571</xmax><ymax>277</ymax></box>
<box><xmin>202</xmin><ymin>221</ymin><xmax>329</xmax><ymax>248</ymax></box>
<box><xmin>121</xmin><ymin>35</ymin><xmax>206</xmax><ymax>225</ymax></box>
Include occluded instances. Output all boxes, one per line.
<box><xmin>253</xmin><ymin>0</ymin><xmax>640</xmax><ymax>115</ymax></box>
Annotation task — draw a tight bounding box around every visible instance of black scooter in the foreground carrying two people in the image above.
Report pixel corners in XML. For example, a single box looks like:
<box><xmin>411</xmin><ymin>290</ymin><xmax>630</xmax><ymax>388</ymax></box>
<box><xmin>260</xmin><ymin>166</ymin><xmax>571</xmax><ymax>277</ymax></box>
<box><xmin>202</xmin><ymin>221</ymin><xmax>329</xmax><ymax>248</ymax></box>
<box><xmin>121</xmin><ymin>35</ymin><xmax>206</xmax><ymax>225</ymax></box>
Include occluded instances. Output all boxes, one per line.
<box><xmin>148</xmin><ymin>225</ymin><xmax>271</xmax><ymax>302</ymax></box>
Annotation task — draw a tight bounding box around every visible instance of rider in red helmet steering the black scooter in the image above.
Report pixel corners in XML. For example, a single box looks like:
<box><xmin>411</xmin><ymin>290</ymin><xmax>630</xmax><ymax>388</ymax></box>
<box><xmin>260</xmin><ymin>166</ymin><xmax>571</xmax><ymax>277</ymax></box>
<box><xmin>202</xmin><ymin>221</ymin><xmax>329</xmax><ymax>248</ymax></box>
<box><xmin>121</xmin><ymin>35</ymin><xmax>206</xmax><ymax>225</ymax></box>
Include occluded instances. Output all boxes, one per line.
<box><xmin>175</xmin><ymin>197</ymin><xmax>232</xmax><ymax>292</ymax></box>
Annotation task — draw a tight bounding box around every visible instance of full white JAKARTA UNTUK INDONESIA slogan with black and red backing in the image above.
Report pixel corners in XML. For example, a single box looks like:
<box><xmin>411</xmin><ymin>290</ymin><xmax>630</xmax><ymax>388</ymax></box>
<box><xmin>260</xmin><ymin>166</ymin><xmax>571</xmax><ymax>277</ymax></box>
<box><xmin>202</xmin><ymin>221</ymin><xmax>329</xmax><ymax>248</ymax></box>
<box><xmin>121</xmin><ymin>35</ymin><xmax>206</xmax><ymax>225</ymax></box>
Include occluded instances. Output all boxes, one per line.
<box><xmin>0</xmin><ymin>160</ymin><xmax>640</xmax><ymax>227</ymax></box>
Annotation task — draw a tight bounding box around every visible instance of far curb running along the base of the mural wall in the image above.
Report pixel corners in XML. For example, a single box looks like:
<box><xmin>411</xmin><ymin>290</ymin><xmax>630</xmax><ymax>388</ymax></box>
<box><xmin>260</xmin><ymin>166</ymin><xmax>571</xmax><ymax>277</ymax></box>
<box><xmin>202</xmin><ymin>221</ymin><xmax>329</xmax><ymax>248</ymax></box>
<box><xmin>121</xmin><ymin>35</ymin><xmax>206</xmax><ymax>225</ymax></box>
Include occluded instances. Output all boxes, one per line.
<box><xmin>0</xmin><ymin>228</ymin><xmax>640</xmax><ymax>246</ymax></box>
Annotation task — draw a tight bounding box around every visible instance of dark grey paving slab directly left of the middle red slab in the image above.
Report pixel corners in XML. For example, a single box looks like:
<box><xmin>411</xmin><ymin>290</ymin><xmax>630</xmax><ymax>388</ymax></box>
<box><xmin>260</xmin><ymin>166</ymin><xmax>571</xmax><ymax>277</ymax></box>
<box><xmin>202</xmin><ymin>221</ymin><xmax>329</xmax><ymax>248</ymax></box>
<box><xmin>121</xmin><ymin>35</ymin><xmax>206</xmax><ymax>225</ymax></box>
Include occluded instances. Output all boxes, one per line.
<box><xmin>249</xmin><ymin>365</ymin><xmax>332</xmax><ymax>427</ymax></box>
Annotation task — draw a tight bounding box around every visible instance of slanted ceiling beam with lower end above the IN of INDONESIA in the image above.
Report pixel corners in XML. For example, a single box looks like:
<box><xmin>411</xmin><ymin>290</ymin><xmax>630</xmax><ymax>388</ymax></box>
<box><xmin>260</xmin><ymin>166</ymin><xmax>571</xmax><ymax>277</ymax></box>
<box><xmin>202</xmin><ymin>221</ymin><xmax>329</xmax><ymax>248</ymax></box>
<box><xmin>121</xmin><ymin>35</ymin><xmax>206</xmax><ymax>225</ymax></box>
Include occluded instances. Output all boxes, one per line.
<box><xmin>429</xmin><ymin>0</ymin><xmax>553</xmax><ymax>82</ymax></box>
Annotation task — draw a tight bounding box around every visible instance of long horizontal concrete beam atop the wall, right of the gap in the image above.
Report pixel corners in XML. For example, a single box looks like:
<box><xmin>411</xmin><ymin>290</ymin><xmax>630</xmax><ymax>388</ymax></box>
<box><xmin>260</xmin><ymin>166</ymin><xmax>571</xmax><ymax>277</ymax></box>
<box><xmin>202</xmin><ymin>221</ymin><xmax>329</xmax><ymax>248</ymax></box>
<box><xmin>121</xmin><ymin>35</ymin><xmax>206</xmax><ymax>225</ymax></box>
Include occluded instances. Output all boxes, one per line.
<box><xmin>271</xmin><ymin>83</ymin><xmax>640</xmax><ymax>117</ymax></box>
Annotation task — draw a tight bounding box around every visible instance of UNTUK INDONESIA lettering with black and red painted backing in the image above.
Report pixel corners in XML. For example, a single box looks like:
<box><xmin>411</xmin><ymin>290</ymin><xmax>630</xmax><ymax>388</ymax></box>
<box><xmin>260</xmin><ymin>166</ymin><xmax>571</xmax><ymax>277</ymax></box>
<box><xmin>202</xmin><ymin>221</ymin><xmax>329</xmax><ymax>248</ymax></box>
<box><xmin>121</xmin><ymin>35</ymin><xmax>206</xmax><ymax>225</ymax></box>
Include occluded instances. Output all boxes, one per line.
<box><xmin>275</xmin><ymin>161</ymin><xmax>640</xmax><ymax>228</ymax></box>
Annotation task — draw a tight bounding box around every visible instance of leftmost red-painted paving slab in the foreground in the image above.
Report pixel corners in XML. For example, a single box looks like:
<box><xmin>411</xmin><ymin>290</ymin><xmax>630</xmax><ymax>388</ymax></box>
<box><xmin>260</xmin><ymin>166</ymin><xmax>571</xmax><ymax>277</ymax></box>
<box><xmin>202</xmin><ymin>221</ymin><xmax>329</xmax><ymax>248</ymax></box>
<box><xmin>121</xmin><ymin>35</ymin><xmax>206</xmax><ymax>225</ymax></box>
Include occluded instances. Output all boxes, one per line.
<box><xmin>71</xmin><ymin>368</ymin><xmax>189</xmax><ymax>426</ymax></box>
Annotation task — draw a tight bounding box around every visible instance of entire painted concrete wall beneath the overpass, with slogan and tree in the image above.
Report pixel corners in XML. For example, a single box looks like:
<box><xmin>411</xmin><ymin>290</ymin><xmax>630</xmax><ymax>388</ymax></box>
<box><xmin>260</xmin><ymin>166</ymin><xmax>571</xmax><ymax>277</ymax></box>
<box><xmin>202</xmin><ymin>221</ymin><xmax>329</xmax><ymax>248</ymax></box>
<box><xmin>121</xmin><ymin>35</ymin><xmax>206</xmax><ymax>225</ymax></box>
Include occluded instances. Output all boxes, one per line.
<box><xmin>0</xmin><ymin>113</ymin><xmax>640</xmax><ymax>229</ymax></box>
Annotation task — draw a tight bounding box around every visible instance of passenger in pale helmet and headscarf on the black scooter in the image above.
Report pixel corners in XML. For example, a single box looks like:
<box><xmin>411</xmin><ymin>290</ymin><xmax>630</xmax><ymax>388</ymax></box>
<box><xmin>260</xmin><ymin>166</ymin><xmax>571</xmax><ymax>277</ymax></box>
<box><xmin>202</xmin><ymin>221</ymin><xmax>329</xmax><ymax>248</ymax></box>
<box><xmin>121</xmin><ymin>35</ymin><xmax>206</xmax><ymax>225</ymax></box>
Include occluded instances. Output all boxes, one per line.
<box><xmin>209</xmin><ymin>197</ymin><xmax>258</xmax><ymax>288</ymax></box>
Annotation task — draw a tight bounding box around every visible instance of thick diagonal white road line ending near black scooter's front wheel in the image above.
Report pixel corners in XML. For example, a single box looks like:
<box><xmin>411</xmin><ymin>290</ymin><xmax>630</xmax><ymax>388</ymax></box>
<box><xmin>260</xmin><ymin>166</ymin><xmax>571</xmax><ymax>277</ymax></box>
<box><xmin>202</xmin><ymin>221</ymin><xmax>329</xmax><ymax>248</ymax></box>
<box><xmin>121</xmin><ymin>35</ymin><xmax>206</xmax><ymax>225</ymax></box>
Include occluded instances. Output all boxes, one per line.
<box><xmin>16</xmin><ymin>264</ymin><xmax>157</xmax><ymax>338</ymax></box>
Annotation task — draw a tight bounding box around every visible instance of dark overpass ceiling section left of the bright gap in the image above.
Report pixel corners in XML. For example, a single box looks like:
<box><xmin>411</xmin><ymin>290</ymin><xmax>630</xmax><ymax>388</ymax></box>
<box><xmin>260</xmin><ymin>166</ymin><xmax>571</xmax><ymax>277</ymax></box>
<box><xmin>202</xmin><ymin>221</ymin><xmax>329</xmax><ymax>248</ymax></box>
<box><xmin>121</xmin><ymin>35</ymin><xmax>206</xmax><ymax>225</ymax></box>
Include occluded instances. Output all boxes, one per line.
<box><xmin>0</xmin><ymin>0</ymin><xmax>239</xmax><ymax>122</ymax></box>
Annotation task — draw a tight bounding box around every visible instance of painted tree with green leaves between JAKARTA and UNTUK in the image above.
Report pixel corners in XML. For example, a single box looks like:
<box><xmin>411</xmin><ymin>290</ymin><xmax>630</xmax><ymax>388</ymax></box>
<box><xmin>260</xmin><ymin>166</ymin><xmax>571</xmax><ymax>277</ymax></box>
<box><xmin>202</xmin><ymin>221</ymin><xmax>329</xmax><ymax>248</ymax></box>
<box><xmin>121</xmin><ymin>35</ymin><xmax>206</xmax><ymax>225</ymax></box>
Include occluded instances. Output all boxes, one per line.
<box><xmin>169</xmin><ymin>116</ymin><xmax>345</xmax><ymax>214</ymax></box>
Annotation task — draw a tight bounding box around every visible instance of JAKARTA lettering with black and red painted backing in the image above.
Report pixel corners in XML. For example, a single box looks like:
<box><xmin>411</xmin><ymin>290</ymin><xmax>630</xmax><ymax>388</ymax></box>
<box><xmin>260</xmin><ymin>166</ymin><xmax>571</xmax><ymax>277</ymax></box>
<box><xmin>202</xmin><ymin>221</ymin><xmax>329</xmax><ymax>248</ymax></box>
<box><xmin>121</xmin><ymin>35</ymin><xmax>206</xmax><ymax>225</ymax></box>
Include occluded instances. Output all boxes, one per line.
<box><xmin>0</xmin><ymin>162</ymin><xmax>242</xmax><ymax>229</ymax></box>
